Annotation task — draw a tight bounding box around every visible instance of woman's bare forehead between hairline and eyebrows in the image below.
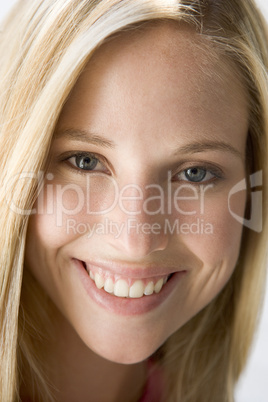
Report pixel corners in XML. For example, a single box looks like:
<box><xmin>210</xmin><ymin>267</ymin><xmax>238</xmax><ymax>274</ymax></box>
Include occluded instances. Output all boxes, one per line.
<box><xmin>59</xmin><ymin>22</ymin><xmax>248</xmax><ymax>150</ymax></box>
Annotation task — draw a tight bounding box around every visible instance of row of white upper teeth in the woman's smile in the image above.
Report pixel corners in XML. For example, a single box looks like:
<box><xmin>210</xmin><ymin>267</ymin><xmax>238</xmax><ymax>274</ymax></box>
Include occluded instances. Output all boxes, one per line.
<box><xmin>89</xmin><ymin>271</ymin><xmax>168</xmax><ymax>298</ymax></box>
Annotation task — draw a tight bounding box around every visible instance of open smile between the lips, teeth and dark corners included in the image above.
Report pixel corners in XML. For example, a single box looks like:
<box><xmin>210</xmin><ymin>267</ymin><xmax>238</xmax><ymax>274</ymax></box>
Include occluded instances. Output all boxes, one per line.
<box><xmin>81</xmin><ymin>261</ymin><xmax>173</xmax><ymax>299</ymax></box>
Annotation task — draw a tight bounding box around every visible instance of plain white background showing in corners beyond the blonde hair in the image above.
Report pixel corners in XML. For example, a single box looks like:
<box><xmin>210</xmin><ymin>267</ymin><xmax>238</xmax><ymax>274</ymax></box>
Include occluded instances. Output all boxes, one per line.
<box><xmin>0</xmin><ymin>0</ymin><xmax>268</xmax><ymax>402</ymax></box>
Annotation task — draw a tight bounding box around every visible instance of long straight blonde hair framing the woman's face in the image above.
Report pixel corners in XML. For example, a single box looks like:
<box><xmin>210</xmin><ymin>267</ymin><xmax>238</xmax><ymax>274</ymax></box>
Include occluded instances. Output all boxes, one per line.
<box><xmin>0</xmin><ymin>0</ymin><xmax>268</xmax><ymax>402</ymax></box>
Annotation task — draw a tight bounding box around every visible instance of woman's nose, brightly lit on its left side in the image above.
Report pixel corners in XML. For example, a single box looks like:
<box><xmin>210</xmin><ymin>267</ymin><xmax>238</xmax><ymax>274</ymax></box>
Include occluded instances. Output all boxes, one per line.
<box><xmin>105</xmin><ymin>183</ymin><xmax>168</xmax><ymax>260</ymax></box>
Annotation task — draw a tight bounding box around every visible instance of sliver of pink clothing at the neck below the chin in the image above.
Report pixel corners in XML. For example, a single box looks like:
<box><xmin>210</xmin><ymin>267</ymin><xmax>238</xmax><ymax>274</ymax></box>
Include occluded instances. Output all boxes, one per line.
<box><xmin>139</xmin><ymin>360</ymin><xmax>164</xmax><ymax>402</ymax></box>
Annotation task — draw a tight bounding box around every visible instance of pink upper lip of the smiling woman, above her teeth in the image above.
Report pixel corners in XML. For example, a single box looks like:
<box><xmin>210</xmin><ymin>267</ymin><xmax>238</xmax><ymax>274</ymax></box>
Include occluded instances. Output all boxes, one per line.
<box><xmin>74</xmin><ymin>259</ymin><xmax>187</xmax><ymax>279</ymax></box>
